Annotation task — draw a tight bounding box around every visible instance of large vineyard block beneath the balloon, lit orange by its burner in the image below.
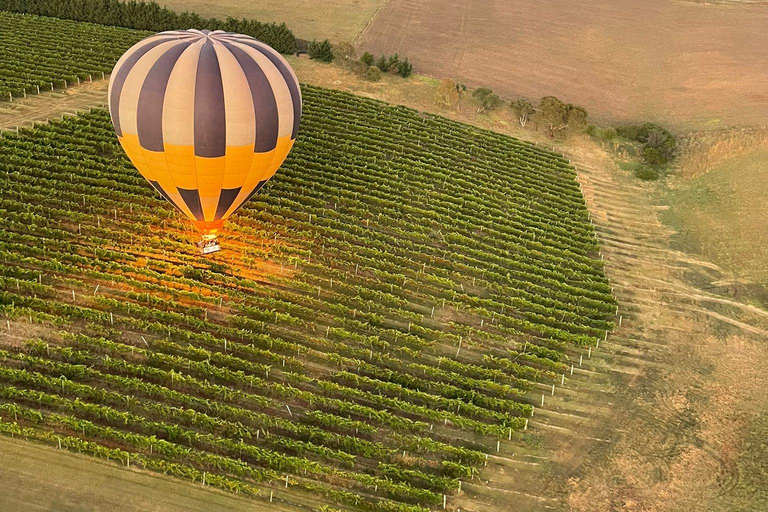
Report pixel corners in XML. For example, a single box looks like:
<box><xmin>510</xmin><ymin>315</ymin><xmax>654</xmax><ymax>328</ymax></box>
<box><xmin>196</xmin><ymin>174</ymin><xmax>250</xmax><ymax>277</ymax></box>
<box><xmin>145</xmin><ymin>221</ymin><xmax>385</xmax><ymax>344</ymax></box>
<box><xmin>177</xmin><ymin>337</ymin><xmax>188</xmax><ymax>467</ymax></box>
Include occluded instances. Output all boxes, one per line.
<box><xmin>0</xmin><ymin>85</ymin><xmax>616</xmax><ymax>512</ymax></box>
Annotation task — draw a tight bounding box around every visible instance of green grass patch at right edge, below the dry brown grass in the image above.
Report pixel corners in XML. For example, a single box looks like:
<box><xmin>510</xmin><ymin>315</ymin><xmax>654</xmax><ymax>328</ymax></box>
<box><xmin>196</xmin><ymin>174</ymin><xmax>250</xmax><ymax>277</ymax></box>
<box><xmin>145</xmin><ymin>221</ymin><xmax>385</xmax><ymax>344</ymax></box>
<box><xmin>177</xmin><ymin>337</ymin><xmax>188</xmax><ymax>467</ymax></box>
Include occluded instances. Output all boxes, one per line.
<box><xmin>665</xmin><ymin>151</ymin><xmax>768</xmax><ymax>286</ymax></box>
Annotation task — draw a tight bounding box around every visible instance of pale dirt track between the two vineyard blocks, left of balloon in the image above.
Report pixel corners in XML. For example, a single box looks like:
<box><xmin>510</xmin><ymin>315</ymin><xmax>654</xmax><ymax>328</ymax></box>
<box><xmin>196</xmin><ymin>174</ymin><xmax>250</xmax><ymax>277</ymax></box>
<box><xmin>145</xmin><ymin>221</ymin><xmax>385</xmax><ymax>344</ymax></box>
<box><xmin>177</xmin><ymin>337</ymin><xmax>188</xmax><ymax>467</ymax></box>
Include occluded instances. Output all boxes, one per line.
<box><xmin>0</xmin><ymin>80</ymin><xmax>109</xmax><ymax>130</ymax></box>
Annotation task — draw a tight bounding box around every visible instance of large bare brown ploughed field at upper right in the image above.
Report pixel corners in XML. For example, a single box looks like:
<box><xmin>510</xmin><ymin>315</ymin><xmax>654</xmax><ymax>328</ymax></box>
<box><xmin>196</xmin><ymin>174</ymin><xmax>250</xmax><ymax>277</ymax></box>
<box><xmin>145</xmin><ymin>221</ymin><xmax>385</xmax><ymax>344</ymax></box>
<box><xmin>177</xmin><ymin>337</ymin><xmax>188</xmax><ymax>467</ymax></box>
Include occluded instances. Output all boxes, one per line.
<box><xmin>359</xmin><ymin>0</ymin><xmax>768</xmax><ymax>128</ymax></box>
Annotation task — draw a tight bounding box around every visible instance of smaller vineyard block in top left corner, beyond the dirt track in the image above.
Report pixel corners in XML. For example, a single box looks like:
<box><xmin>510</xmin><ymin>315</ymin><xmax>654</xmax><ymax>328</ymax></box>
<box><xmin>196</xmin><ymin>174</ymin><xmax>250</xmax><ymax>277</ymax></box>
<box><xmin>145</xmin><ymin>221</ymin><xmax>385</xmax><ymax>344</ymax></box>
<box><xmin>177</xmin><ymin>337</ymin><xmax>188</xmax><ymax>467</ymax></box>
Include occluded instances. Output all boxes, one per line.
<box><xmin>0</xmin><ymin>11</ymin><xmax>149</xmax><ymax>101</ymax></box>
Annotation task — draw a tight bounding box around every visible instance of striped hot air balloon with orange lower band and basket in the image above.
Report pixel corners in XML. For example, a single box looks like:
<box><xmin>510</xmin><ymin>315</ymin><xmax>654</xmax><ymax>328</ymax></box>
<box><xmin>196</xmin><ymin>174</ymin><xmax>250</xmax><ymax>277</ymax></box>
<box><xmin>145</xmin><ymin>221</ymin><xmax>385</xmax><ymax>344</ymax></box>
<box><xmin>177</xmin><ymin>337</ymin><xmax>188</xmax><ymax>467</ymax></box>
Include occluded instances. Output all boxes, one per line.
<box><xmin>108</xmin><ymin>30</ymin><xmax>301</xmax><ymax>254</ymax></box>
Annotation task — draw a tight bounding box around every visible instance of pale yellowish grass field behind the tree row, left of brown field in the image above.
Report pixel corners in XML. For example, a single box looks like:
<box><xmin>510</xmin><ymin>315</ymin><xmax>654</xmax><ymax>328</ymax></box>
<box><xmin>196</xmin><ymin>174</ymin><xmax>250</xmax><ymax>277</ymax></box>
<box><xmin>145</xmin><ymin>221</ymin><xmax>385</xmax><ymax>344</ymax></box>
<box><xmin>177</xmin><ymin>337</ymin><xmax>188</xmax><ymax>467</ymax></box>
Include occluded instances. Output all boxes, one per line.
<box><xmin>159</xmin><ymin>0</ymin><xmax>386</xmax><ymax>43</ymax></box>
